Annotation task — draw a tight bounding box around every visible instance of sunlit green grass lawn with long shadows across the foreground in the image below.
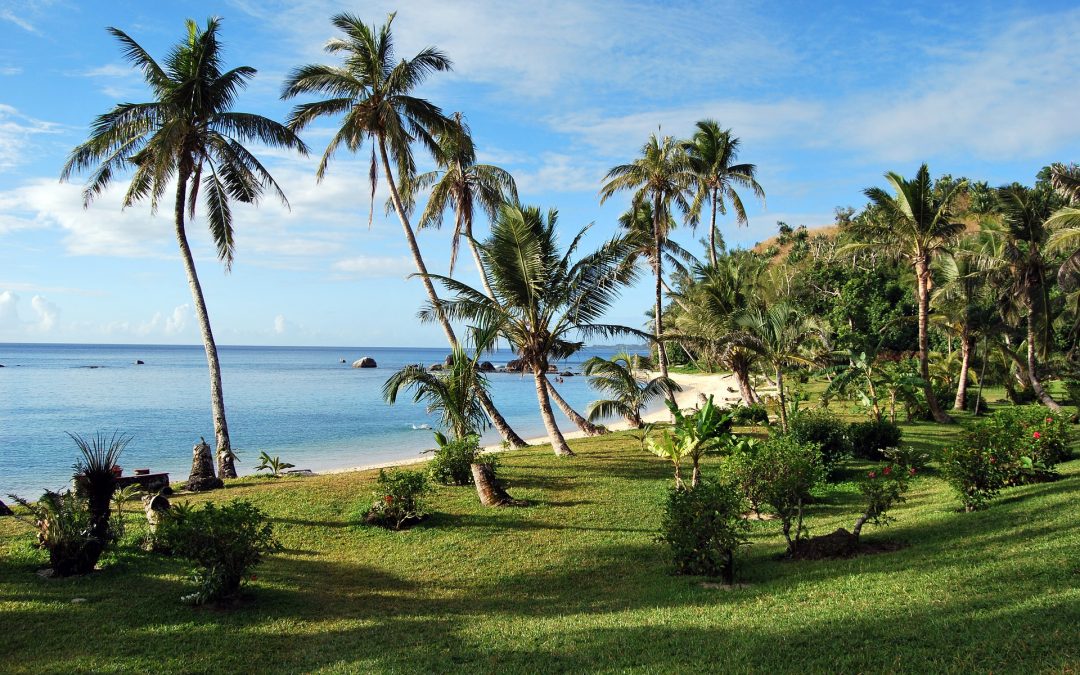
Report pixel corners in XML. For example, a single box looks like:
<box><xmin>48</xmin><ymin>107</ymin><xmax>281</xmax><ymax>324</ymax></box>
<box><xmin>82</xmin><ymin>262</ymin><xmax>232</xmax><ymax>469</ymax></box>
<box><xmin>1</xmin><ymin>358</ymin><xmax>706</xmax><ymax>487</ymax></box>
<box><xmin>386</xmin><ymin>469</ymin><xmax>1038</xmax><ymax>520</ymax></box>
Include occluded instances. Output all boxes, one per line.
<box><xmin>0</xmin><ymin>408</ymin><xmax>1080</xmax><ymax>673</ymax></box>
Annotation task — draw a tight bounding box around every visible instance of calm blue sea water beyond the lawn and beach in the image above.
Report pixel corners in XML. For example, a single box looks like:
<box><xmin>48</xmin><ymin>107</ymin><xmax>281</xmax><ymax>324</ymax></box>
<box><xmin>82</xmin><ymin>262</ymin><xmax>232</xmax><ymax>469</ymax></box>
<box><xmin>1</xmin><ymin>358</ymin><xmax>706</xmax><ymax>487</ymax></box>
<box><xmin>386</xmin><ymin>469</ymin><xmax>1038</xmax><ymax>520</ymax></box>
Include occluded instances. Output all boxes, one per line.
<box><xmin>0</xmin><ymin>345</ymin><xmax>630</xmax><ymax>497</ymax></box>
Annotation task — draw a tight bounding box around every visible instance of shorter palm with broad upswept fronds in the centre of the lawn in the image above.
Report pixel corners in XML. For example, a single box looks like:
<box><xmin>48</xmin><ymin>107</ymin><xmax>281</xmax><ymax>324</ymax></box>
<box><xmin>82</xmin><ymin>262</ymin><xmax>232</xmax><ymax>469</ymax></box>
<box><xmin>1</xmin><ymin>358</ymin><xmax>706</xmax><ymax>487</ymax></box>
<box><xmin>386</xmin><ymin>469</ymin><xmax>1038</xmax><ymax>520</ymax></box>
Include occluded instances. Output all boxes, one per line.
<box><xmin>421</xmin><ymin>204</ymin><xmax>642</xmax><ymax>456</ymax></box>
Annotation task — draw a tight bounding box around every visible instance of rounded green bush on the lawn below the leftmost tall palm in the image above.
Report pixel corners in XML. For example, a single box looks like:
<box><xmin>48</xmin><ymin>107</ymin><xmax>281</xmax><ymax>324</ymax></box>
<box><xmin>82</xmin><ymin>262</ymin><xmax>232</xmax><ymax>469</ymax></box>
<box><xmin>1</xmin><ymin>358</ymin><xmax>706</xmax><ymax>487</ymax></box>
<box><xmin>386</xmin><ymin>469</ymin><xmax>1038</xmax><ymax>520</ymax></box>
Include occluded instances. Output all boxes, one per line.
<box><xmin>156</xmin><ymin>500</ymin><xmax>281</xmax><ymax>605</ymax></box>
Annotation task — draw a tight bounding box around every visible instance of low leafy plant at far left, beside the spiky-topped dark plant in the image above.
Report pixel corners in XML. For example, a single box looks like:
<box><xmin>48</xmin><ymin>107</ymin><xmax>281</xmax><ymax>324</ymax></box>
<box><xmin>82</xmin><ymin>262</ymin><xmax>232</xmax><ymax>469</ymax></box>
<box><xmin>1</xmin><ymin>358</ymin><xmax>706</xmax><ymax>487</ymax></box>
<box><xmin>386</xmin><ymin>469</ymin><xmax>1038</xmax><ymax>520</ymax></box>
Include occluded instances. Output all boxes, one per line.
<box><xmin>9</xmin><ymin>490</ymin><xmax>99</xmax><ymax>577</ymax></box>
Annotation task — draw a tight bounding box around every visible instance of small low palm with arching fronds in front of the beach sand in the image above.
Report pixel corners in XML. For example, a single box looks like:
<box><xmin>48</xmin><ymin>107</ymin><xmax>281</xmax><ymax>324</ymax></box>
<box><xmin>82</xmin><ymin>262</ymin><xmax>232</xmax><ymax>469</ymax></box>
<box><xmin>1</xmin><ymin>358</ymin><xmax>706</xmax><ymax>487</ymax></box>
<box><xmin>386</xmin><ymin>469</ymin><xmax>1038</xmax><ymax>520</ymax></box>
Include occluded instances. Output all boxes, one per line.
<box><xmin>584</xmin><ymin>352</ymin><xmax>683</xmax><ymax>429</ymax></box>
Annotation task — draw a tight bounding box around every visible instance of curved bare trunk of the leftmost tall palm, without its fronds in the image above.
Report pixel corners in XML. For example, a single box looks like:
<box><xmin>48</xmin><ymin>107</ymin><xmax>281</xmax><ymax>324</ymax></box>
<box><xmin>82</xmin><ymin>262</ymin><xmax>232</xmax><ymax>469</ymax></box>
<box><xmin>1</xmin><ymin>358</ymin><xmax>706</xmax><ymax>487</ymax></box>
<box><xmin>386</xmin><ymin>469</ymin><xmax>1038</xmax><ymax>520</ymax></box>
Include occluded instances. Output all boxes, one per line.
<box><xmin>175</xmin><ymin>166</ymin><xmax>237</xmax><ymax>478</ymax></box>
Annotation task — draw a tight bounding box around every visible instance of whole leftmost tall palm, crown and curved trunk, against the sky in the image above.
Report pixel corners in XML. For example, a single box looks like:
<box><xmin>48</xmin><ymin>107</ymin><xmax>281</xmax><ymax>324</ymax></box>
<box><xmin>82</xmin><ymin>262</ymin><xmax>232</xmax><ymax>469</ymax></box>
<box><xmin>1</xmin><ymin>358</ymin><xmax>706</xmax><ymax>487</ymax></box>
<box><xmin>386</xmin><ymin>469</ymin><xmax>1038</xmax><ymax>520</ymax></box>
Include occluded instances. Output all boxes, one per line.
<box><xmin>60</xmin><ymin>18</ymin><xmax>307</xmax><ymax>477</ymax></box>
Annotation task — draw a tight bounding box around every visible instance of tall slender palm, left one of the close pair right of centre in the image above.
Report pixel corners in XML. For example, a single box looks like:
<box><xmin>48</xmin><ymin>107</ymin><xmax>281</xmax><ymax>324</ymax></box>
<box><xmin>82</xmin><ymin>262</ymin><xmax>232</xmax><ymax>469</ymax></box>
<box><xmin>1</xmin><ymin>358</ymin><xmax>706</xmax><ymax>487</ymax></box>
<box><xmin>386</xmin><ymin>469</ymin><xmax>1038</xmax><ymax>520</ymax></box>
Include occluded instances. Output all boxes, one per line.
<box><xmin>600</xmin><ymin>134</ymin><xmax>692</xmax><ymax>384</ymax></box>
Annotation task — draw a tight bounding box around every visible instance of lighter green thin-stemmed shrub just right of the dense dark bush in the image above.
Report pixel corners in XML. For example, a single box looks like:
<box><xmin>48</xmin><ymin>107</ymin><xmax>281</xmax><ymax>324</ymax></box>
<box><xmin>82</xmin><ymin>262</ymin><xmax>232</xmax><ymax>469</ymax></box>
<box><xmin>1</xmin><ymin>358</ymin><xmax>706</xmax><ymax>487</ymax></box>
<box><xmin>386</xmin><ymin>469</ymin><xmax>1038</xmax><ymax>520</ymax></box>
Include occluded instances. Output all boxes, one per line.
<box><xmin>727</xmin><ymin>434</ymin><xmax>824</xmax><ymax>555</ymax></box>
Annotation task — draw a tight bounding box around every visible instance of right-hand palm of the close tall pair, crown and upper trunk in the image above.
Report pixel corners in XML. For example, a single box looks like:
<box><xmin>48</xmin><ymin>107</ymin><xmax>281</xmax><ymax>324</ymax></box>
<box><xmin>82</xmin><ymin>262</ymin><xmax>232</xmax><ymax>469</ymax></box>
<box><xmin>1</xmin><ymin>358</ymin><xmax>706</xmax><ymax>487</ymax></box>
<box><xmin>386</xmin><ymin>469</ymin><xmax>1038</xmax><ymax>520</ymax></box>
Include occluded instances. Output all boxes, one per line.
<box><xmin>683</xmin><ymin>120</ymin><xmax>765</xmax><ymax>265</ymax></box>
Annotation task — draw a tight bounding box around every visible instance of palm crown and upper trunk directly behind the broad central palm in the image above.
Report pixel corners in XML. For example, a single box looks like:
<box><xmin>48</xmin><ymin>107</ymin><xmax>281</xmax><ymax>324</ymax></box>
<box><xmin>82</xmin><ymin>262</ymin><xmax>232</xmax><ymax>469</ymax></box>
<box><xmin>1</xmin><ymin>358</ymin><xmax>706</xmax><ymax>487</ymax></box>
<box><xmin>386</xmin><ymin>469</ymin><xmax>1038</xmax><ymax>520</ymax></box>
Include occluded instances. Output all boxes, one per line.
<box><xmin>406</xmin><ymin>112</ymin><xmax>517</xmax><ymax>295</ymax></box>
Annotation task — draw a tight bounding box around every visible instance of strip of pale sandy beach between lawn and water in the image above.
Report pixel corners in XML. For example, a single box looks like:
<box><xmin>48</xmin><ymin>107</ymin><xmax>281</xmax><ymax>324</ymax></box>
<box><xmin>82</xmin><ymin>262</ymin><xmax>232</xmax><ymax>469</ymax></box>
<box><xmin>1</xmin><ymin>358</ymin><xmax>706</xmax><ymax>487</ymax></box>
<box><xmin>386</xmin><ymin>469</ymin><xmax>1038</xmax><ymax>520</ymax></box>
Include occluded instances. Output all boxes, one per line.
<box><xmin>312</xmin><ymin>373</ymin><xmax>742</xmax><ymax>475</ymax></box>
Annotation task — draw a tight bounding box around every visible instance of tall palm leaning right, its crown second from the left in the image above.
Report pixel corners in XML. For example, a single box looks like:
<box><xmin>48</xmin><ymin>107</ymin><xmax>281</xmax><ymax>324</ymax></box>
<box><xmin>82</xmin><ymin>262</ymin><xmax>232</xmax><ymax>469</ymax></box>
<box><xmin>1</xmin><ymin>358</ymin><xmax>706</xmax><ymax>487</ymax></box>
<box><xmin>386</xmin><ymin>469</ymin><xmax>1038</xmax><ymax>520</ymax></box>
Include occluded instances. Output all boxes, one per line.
<box><xmin>282</xmin><ymin>13</ymin><xmax>526</xmax><ymax>447</ymax></box>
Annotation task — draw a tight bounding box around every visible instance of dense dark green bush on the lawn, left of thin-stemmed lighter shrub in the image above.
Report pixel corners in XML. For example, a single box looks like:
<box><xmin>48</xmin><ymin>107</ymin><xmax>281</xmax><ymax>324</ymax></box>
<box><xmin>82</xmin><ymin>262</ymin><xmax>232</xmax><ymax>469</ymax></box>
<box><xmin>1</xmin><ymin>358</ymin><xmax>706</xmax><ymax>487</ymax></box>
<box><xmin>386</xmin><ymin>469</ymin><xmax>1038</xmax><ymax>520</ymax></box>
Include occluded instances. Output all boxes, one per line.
<box><xmin>658</xmin><ymin>481</ymin><xmax>748</xmax><ymax>583</ymax></box>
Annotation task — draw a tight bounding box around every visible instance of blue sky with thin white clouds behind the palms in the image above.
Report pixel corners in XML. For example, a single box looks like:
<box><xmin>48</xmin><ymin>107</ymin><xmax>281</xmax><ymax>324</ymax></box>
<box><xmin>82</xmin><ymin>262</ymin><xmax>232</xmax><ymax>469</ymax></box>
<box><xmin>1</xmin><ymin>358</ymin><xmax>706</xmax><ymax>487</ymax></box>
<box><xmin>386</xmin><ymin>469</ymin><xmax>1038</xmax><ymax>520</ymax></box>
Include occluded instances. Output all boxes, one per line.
<box><xmin>0</xmin><ymin>0</ymin><xmax>1080</xmax><ymax>346</ymax></box>
